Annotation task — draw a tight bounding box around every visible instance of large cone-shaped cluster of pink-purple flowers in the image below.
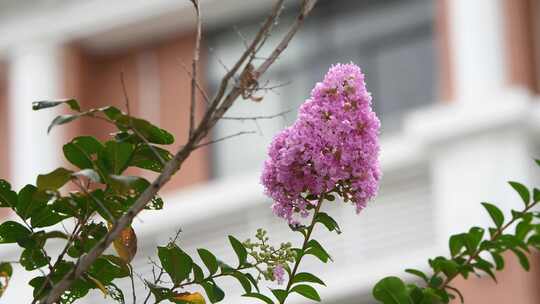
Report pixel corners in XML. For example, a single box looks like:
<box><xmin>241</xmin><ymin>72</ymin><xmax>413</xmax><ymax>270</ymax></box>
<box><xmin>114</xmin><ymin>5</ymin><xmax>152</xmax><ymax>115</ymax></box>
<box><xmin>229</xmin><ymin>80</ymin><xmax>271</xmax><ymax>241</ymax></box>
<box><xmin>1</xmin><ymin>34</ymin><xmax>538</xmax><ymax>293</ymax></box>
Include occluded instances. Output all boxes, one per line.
<box><xmin>261</xmin><ymin>64</ymin><xmax>381</xmax><ymax>223</ymax></box>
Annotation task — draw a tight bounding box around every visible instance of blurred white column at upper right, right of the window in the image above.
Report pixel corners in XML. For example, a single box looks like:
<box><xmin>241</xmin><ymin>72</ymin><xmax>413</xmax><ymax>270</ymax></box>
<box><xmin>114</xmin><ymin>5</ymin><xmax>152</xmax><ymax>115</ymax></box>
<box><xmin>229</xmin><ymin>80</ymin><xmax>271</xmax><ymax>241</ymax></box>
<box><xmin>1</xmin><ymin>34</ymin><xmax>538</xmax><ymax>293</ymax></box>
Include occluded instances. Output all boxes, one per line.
<box><xmin>448</xmin><ymin>0</ymin><xmax>505</xmax><ymax>103</ymax></box>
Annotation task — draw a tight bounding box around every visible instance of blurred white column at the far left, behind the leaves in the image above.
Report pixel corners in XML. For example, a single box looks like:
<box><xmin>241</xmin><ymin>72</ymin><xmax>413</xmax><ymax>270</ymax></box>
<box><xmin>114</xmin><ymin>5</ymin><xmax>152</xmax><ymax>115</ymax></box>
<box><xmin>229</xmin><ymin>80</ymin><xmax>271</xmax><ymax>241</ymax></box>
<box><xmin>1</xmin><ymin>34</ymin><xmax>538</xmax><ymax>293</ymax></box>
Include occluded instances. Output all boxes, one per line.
<box><xmin>8</xmin><ymin>42</ymin><xmax>63</xmax><ymax>188</ymax></box>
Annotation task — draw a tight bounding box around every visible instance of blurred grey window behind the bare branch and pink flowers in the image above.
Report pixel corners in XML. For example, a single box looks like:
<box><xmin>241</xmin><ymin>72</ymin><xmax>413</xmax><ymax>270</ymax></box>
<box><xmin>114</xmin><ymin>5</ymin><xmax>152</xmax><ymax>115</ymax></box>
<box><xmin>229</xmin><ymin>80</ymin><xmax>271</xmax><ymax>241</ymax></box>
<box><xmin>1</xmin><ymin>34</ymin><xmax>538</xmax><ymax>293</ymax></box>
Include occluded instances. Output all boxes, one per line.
<box><xmin>208</xmin><ymin>0</ymin><xmax>436</xmax><ymax>177</ymax></box>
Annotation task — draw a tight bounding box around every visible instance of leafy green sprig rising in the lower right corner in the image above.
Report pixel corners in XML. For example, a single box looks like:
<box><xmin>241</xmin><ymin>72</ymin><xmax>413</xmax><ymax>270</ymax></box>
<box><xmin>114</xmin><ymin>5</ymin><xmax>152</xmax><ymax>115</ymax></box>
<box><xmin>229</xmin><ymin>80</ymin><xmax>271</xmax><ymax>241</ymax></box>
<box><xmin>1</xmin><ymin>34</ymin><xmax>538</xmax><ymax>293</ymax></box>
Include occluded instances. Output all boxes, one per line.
<box><xmin>373</xmin><ymin>161</ymin><xmax>540</xmax><ymax>304</ymax></box>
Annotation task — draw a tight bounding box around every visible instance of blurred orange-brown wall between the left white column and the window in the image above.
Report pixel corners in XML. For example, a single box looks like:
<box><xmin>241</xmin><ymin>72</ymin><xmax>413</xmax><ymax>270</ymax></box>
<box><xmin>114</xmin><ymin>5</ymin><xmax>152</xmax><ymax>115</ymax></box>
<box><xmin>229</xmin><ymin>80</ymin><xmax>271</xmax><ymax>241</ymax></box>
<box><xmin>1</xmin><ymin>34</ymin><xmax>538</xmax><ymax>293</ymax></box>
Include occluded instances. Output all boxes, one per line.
<box><xmin>65</xmin><ymin>36</ymin><xmax>210</xmax><ymax>191</ymax></box>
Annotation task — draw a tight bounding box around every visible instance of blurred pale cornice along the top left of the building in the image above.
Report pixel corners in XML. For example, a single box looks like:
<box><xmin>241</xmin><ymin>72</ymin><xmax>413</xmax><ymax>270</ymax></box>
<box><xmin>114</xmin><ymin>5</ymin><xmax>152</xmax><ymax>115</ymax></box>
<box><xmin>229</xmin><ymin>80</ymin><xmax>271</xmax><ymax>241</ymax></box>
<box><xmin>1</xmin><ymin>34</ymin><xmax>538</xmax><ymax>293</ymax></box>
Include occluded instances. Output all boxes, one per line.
<box><xmin>0</xmin><ymin>0</ymin><xmax>272</xmax><ymax>54</ymax></box>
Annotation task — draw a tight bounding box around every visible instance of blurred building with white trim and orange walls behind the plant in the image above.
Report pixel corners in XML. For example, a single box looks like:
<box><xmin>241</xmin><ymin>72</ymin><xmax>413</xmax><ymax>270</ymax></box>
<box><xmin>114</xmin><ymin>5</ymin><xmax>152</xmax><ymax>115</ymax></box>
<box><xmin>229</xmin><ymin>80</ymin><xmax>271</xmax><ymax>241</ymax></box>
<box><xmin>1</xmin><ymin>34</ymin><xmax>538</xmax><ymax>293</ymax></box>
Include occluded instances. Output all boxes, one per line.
<box><xmin>0</xmin><ymin>0</ymin><xmax>540</xmax><ymax>304</ymax></box>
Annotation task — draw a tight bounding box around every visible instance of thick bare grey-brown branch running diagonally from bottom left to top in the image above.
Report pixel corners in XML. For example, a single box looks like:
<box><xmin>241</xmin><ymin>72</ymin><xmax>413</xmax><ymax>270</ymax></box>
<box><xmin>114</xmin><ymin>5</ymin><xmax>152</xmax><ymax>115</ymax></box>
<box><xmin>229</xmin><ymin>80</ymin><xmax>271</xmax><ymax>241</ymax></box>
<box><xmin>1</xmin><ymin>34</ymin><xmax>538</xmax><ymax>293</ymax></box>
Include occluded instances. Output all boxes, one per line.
<box><xmin>42</xmin><ymin>0</ymin><xmax>317</xmax><ymax>304</ymax></box>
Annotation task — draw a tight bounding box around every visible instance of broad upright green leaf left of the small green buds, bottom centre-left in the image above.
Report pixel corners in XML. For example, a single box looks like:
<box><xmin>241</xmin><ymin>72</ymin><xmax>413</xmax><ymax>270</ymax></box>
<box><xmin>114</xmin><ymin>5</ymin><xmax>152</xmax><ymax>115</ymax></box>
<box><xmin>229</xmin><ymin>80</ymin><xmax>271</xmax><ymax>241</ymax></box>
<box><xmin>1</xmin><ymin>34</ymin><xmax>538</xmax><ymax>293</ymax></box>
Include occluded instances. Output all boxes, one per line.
<box><xmin>158</xmin><ymin>243</ymin><xmax>193</xmax><ymax>284</ymax></box>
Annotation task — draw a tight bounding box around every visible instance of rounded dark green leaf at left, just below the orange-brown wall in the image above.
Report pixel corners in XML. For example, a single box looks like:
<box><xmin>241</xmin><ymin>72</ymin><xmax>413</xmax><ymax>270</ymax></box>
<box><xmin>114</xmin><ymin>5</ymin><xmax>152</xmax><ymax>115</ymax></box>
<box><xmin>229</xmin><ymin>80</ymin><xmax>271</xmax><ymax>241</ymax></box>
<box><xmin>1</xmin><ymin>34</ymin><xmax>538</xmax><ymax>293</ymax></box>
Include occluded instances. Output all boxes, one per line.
<box><xmin>63</xmin><ymin>136</ymin><xmax>104</xmax><ymax>169</ymax></box>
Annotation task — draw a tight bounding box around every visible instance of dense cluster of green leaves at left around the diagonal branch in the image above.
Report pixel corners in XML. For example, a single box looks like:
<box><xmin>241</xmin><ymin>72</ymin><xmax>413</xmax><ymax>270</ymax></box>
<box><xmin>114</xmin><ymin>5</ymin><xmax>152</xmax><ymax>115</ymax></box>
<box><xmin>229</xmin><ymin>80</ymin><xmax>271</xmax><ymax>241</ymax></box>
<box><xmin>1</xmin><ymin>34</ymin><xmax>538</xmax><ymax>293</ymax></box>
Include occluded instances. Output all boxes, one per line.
<box><xmin>0</xmin><ymin>99</ymin><xmax>174</xmax><ymax>303</ymax></box>
